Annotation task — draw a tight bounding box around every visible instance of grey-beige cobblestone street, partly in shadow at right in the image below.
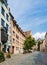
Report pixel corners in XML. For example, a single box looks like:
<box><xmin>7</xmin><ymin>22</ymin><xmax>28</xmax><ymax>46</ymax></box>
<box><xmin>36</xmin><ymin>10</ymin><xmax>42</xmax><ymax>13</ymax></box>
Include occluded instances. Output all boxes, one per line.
<box><xmin>0</xmin><ymin>52</ymin><xmax>47</xmax><ymax>65</ymax></box>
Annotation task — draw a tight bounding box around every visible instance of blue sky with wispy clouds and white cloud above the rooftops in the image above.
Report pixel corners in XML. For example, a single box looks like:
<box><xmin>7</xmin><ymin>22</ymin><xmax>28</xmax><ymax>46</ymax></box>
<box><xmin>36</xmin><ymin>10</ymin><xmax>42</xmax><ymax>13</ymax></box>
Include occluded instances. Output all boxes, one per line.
<box><xmin>8</xmin><ymin>0</ymin><xmax>47</xmax><ymax>38</ymax></box>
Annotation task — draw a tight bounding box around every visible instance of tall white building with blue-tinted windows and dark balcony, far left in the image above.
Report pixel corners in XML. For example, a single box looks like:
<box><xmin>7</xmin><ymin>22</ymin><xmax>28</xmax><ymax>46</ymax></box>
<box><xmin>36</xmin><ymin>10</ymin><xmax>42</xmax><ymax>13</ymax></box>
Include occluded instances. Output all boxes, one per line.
<box><xmin>0</xmin><ymin>0</ymin><xmax>11</xmax><ymax>52</ymax></box>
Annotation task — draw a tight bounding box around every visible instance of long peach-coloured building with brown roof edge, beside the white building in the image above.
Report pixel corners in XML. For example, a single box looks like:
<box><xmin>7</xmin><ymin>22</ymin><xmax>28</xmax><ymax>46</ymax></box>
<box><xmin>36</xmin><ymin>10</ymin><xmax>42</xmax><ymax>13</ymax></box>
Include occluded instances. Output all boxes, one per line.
<box><xmin>11</xmin><ymin>20</ymin><xmax>26</xmax><ymax>54</ymax></box>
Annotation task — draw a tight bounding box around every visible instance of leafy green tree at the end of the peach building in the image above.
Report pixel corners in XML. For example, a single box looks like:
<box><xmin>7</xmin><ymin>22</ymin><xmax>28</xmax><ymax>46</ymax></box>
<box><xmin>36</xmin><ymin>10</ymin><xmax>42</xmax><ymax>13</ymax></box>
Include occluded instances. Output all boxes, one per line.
<box><xmin>23</xmin><ymin>36</ymin><xmax>35</xmax><ymax>51</ymax></box>
